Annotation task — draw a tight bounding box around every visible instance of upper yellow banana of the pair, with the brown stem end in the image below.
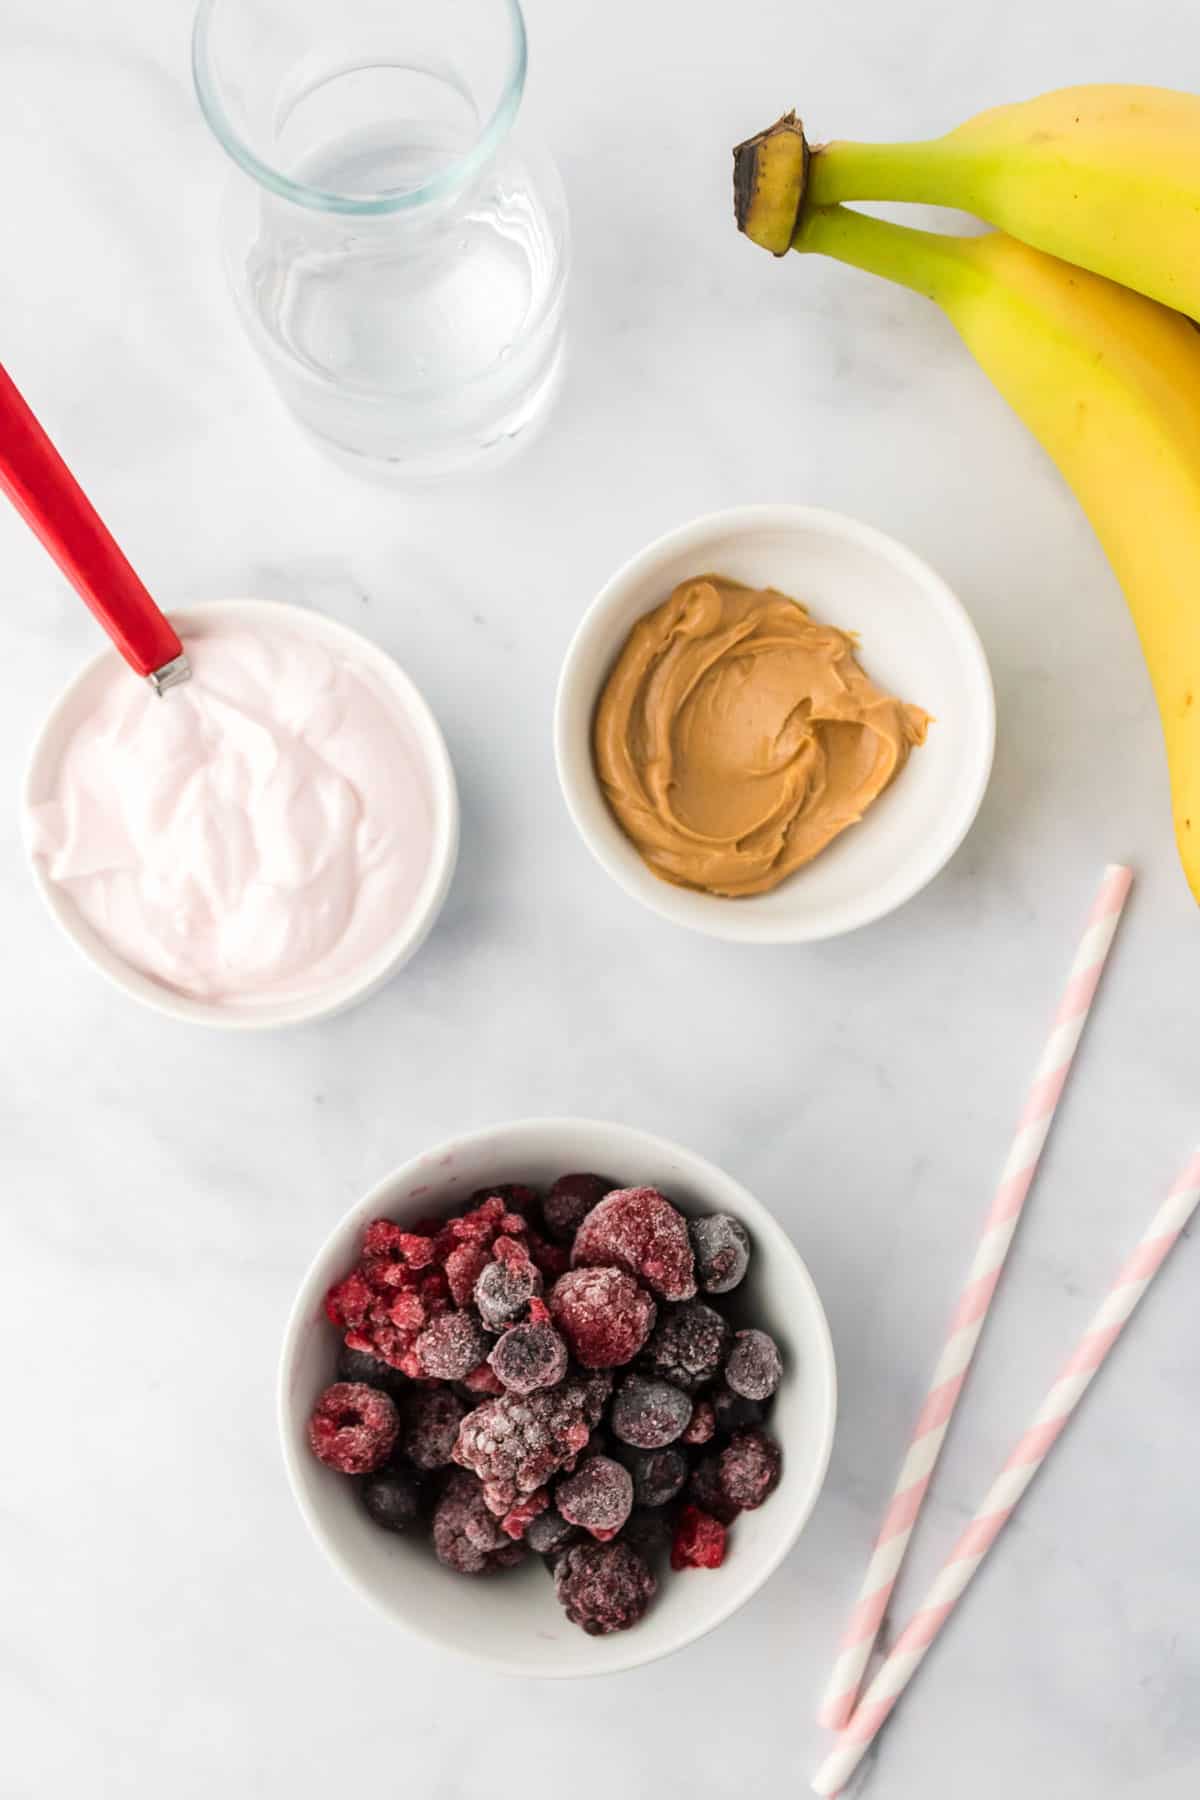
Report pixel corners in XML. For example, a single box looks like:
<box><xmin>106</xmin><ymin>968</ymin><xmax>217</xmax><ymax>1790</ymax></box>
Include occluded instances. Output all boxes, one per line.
<box><xmin>734</xmin><ymin>85</ymin><xmax>1200</xmax><ymax>319</ymax></box>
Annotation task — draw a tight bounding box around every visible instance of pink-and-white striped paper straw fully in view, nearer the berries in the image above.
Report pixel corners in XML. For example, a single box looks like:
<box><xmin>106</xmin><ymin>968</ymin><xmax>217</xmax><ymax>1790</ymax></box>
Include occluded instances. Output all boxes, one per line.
<box><xmin>817</xmin><ymin>862</ymin><xmax>1133</xmax><ymax>1730</ymax></box>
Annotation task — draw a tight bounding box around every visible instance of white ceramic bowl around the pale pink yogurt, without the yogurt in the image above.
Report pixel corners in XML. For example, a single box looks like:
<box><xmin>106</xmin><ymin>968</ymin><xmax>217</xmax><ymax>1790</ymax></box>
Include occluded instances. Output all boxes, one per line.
<box><xmin>23</xmin><ymin>599</ymin><xmax>459</xmax><ymax>1031</ymax></box>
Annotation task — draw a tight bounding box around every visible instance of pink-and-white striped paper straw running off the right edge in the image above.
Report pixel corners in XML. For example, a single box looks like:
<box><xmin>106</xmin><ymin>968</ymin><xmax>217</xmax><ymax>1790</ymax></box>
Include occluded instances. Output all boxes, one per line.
<box><xmin>813</xmin><ymin>1150</ymin><xmax>1200</xmax><ymax>1795</ymax></box>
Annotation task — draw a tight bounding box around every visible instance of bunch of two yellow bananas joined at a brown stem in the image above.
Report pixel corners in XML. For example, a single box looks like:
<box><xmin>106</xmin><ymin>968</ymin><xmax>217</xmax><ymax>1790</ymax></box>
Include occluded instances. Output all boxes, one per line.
<box><xmin>734</xmin><ymin>86</ymin><xmax>1200</xmax><ymax>902</ymax></box>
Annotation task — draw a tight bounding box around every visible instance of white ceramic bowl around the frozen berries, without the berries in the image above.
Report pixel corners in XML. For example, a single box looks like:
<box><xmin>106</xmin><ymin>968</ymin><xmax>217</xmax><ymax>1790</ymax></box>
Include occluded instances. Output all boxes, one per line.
<box><xmin>279</xmin><ymin>1120</ymin><xmax>837</xmax><ymax>1678</ymax></box>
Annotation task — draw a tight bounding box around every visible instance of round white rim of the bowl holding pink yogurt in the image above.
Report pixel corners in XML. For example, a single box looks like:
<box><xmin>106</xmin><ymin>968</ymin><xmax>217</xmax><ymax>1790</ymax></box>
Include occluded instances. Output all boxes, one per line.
<box><xmin>22</xmin><ymin>596</ymin><xmax>461</xmax><ymax>1031</ymax></box>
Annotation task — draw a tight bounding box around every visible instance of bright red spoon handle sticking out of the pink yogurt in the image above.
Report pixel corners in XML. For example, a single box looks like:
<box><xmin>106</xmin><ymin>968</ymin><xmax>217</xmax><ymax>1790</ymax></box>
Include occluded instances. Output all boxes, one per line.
<box><xmin>0</xmin><ymin>365</ymin><xmax>184</xmax><ymax>675</ymax></box>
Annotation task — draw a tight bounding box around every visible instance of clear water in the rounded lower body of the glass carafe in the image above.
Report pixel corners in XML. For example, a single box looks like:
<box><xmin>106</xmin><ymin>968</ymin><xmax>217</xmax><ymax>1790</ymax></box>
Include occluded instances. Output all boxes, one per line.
<box><xmin>243</xmin><ymin>76</ymin><xmax>565</xmax><ymax>470</ymax></box>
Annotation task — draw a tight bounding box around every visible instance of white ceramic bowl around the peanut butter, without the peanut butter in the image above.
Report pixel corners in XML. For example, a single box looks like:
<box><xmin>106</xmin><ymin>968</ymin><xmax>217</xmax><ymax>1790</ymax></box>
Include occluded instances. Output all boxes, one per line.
<box><xmin>554</xmin><ymin>506</ymin><xmax>995</xmax><ymax>943</ymax></box>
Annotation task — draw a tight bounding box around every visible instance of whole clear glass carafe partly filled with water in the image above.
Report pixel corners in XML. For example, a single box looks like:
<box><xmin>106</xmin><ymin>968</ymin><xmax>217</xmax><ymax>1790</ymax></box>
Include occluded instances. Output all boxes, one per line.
<box><xmin>193</xmin><ymin>0</ymin><xmax>567</xmax><ymax>473</ymax></box>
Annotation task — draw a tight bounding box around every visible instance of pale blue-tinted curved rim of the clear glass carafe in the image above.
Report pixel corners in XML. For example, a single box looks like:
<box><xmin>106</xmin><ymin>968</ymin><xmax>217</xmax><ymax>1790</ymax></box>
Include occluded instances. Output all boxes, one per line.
<box><xmin>193</xmin><ymin>0</ymin><xmax>529</xmax><ymax>216</ymax></box>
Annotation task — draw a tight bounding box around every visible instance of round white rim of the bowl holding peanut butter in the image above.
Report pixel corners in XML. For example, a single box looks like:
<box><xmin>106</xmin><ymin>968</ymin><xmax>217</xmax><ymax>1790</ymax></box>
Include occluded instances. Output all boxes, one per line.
<box><xmin>554</xmin><ymin>500</ymin><xmax>997</xmax><ymax>943</ymax></box>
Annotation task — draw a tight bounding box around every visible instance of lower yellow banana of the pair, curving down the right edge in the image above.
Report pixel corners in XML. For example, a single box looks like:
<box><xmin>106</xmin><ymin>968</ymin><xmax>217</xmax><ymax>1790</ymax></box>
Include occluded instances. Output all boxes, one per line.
<box><xmin>773</xmin><ymin>207</ymin><xmax>1200</xmax><ymax>900</ymax></box>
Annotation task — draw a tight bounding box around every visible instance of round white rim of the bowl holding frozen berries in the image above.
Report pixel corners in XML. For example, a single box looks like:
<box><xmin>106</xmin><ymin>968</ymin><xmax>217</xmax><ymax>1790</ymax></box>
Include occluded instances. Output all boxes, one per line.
<box><xmin>277</xmin><ymin>1114</ymin><xmax>838</xmax><ymax>1681</ymax></box>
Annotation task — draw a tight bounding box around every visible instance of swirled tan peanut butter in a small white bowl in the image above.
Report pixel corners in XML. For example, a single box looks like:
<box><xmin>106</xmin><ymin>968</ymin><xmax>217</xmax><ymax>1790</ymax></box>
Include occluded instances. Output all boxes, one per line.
<box><xmin>594</xmin><ymin>576</ymin><xmax>928</xmax><ymax>896</ymax></box>
